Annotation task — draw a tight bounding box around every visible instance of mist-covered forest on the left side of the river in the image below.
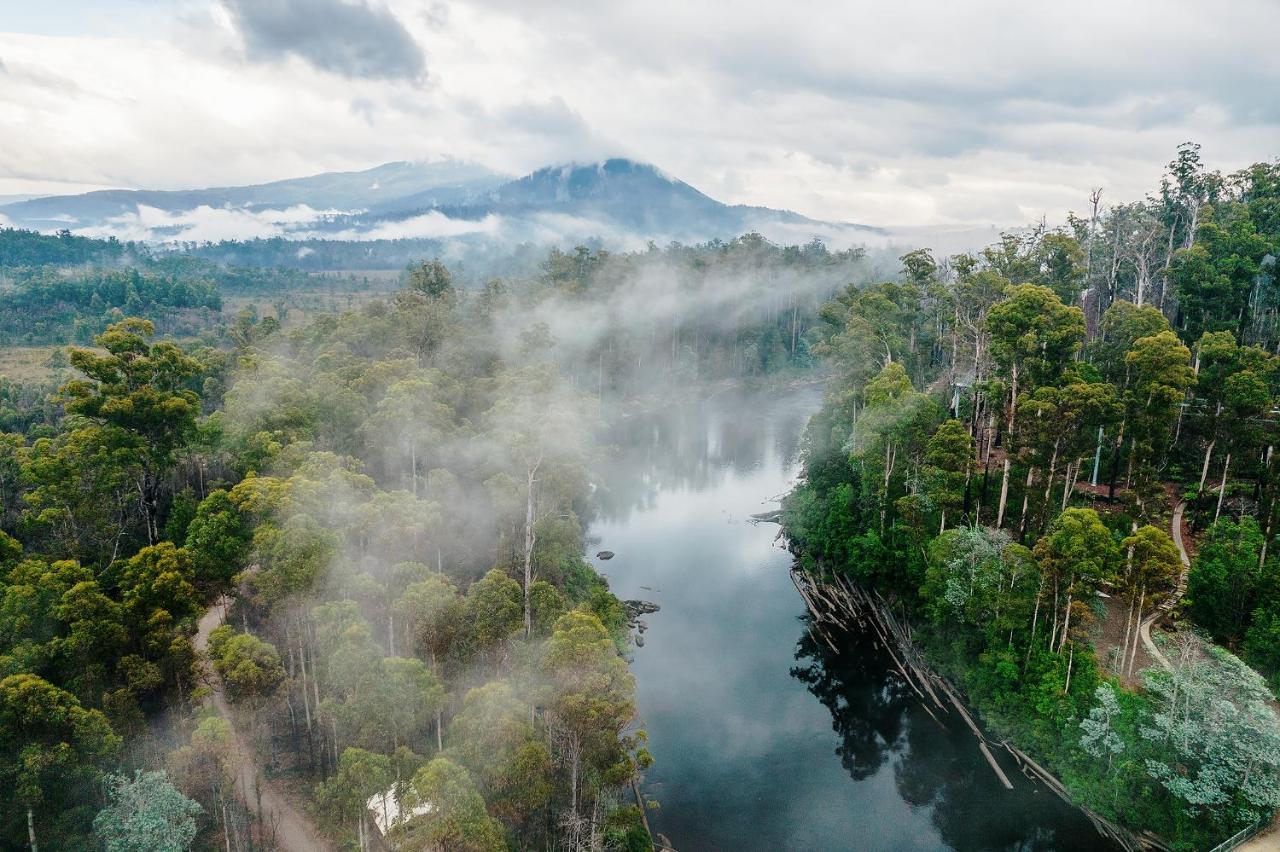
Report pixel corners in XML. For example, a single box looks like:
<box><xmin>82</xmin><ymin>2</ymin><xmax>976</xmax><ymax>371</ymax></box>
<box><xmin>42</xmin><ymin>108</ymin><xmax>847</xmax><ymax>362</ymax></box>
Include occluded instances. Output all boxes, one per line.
<box><xmin>0</xmin><ymin>222</ymin><xmax>863</xmax><ymax>851</ymax></box>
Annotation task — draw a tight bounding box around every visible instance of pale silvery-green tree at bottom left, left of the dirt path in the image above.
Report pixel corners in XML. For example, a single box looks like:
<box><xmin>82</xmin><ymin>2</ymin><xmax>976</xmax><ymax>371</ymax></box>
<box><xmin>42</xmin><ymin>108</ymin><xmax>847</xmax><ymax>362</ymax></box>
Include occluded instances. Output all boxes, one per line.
<box><xmin>93</xmin><ymin>769</ymin><xmax>204</xmax><ymax>852</ymax></box>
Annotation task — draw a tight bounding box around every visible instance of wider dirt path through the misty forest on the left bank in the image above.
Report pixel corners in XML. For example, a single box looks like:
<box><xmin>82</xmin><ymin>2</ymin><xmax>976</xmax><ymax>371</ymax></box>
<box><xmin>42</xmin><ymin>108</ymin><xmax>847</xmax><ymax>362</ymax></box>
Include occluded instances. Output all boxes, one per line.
<box><xmin>196</xmin><ymin>597</ymin><xmax>334</xmax><ymax>852</ymax></box>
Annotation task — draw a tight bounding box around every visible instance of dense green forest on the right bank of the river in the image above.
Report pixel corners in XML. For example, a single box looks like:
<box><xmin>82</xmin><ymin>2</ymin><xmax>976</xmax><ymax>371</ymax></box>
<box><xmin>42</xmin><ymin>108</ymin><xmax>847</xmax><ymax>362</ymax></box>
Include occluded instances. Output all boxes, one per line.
<box><xmin>783</xmin><ymin>145</ymin><xmax>1280</xmax><ymax>849</ymax></box>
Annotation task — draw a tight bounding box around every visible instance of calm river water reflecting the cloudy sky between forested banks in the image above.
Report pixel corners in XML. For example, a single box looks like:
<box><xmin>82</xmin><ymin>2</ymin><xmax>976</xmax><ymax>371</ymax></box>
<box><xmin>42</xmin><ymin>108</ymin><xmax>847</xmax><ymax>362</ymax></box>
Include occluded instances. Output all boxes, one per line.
<box><xmin>591</xmin><ymin>389</ymin><xmax>1102</xmax><ymax>852</ymax></box>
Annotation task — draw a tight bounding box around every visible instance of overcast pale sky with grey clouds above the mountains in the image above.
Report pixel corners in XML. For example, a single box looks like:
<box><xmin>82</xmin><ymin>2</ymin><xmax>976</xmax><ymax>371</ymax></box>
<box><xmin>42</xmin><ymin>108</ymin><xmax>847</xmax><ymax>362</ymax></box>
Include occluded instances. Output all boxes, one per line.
<box><xmin>0</xmin><ymin>0</ymin><xmax>1280</xmax><ymax>225</ymax></box>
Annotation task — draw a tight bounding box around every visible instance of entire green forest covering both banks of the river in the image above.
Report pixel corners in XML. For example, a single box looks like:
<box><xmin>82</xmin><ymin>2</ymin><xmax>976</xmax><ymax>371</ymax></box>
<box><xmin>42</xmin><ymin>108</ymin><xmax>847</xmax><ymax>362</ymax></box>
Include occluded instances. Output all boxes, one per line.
<box><xmin>0</xmin><ymin>139</ymin><xmax>1280</xmax><ymax>851</ymax></box>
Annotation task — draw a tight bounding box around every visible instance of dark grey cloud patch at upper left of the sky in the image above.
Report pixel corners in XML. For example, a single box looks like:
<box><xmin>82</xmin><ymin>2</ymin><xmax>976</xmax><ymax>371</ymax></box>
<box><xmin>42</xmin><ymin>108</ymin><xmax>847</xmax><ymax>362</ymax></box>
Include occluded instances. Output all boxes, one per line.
<box><xmin>223</xmin><ymin>0</ymin><xmax>426</xmax><ymax>79</ymax></box>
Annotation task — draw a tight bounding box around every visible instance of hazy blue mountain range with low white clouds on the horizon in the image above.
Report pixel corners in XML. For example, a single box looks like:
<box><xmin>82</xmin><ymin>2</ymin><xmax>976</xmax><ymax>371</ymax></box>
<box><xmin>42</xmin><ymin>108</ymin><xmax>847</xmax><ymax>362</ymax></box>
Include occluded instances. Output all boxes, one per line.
<box><xmin>0</xmin><ymin>159</ymin><xmax>881</xmax><ymax>244</ymax></box>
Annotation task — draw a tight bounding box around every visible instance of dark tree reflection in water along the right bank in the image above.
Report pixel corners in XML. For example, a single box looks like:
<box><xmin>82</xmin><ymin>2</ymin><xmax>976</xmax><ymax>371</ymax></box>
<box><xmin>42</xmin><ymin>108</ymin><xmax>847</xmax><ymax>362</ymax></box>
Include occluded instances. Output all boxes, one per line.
<box><xmin>791</xmin><ymin>615</ymin><xmax>1107</xmax><ymax>852</ymax></box>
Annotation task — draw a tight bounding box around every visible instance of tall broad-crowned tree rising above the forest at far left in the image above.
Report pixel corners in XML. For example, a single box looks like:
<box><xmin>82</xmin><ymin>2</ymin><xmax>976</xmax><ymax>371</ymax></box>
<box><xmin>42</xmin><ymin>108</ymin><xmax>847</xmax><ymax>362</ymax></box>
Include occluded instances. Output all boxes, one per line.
<box><xmin>61</xmin><ymin>319</ymin><xmax>201</xmax><ymax>544</ymax></box>
